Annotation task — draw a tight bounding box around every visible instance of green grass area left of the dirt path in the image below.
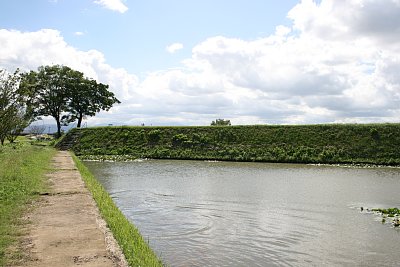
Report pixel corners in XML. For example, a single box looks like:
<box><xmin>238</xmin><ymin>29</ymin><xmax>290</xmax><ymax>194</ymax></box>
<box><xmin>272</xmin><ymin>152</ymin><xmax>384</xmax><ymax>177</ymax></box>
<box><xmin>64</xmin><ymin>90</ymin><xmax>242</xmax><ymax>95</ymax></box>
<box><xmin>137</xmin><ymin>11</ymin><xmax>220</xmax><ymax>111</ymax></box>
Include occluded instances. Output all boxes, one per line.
<box><xmin>0</xmin><ymin>141</ymin><xmax>55</xmax><ymax>266</ymax></box>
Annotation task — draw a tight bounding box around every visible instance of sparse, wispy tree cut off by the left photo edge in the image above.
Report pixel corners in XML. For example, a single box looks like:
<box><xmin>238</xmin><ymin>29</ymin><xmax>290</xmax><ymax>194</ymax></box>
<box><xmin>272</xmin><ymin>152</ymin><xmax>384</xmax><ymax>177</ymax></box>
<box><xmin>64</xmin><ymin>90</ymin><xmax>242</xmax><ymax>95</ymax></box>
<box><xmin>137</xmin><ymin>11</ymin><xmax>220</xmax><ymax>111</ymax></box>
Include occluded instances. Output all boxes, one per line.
<box><xmin>0</xmin><ymin>69</ymin><xmax>33</xmax><ymax>145</ymax></box>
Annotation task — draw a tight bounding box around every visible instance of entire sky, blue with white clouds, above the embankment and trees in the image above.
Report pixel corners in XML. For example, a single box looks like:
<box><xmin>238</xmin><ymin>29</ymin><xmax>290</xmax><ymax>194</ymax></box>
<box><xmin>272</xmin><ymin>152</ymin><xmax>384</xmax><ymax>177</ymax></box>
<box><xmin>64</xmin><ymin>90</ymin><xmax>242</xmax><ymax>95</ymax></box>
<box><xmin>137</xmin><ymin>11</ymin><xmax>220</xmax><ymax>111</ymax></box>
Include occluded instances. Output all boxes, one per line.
<box><xmin>0</xmin><ymin>0</ymin><xmax>400</xmax><ymax>126</ymax></box>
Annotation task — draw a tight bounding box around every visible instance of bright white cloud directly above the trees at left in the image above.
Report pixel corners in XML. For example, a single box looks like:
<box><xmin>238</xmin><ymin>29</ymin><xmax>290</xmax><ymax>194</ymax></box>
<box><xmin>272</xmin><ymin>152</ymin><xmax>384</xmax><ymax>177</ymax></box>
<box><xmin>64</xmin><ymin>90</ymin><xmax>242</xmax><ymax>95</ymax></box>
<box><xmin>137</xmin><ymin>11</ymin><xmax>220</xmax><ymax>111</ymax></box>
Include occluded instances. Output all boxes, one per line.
<box><xmin>0</xmin><ymin>29</ymin><xmax>138</xmax><ymax>124</ymax></box>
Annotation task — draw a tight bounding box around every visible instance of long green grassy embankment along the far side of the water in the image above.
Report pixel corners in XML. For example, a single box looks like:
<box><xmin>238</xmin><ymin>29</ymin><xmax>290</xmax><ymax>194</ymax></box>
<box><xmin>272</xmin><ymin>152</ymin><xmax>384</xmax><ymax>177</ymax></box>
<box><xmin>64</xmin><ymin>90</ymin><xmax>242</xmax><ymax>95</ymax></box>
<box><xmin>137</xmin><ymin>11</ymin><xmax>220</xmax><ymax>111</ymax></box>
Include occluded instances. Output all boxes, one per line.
<box><xmin>64</xmin><ymin>124</ymin><xmax>400</xmax><ymax>165</ymax></box>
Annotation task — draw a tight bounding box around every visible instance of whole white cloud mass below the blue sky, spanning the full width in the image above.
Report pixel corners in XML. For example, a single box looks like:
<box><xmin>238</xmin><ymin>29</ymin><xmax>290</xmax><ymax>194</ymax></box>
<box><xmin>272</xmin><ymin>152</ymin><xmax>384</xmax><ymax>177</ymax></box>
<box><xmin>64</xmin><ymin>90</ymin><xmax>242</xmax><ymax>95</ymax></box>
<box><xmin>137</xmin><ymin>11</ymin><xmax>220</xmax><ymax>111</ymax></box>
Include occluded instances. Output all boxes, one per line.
<box><xmin>0</xmin><ymin>0</ymin><xmax>400</xmax><ymax>125</ymax></box>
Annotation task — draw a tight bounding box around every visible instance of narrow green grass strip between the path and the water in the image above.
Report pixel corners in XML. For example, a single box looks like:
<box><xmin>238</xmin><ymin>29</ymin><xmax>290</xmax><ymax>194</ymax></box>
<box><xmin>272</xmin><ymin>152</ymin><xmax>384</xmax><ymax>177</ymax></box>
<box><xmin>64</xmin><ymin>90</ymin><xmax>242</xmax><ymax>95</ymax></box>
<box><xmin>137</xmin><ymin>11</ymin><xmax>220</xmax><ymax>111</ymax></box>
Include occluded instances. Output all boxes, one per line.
<box><xmin>73</xmin><ymin>155</ymin><xmax>163</xmax><ymax>267</ymax></box>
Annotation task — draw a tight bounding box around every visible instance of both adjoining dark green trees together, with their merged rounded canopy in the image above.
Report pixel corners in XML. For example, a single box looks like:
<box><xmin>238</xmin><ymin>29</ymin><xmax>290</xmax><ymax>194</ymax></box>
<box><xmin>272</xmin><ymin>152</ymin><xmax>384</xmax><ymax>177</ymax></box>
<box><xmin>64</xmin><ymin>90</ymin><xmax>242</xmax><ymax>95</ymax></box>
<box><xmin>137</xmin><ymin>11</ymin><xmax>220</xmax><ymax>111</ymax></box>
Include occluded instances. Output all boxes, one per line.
<box><xmin>21</xmin><ymin>65</ymin><xmax>120</xmax><ymax>136</ymax></box>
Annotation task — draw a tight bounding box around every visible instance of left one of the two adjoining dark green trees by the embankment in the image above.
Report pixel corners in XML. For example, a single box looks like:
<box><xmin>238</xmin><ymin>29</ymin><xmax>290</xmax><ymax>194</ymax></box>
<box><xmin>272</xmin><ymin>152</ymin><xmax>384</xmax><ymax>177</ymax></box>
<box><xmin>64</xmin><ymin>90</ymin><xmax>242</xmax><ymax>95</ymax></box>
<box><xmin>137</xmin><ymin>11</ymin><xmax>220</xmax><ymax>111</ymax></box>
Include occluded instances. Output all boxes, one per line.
<box><xmin>22</xmin><ymin>65</ymin><xmax>73</xmax><ymax>137</ymax></box>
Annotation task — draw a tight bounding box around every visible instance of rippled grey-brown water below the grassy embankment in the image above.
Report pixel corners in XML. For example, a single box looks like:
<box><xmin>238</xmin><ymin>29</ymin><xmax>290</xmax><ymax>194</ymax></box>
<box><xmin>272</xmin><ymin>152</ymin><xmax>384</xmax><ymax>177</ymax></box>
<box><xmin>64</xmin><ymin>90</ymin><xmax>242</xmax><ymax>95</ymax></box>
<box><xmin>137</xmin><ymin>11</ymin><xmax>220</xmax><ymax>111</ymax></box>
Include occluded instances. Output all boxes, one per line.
<box><xmin>85</xmin><ymin>160</ymin><xmax>400</xmax><ymax>266</ymax></box>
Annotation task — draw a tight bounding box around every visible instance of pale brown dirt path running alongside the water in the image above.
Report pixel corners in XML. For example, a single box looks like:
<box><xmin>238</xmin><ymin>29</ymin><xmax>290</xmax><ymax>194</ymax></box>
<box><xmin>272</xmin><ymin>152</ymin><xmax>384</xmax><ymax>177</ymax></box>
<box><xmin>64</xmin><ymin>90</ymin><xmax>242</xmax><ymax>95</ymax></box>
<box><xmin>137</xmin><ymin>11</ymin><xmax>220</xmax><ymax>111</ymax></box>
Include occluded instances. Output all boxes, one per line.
<box><xmin>15</xmin><ymin>151</ymin><xmax>127</xmax><ymax>267</ymax></box>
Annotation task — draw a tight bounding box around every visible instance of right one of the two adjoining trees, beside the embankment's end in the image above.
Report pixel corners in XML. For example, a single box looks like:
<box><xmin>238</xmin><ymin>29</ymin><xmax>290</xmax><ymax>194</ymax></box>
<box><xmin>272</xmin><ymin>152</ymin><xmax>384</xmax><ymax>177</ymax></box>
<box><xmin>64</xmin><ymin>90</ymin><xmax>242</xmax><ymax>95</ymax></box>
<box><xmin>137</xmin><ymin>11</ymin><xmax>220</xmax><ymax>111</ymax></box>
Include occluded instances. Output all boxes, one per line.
<box><xmin>67</xmin><ymin>73</ymin><xmax>121</xmax><ymax>128</ymax></box>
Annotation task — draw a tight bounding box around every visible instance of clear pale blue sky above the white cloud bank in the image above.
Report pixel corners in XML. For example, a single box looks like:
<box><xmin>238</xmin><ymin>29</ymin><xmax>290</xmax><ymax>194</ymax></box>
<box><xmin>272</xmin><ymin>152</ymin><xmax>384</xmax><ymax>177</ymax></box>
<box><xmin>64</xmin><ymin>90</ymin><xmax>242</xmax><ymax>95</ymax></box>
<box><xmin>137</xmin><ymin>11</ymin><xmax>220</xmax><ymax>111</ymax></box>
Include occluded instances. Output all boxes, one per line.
<box><xmin>0</xmin><ymin>0</ymin><xmax>297</xmax><ymax>73</ymax></box>
